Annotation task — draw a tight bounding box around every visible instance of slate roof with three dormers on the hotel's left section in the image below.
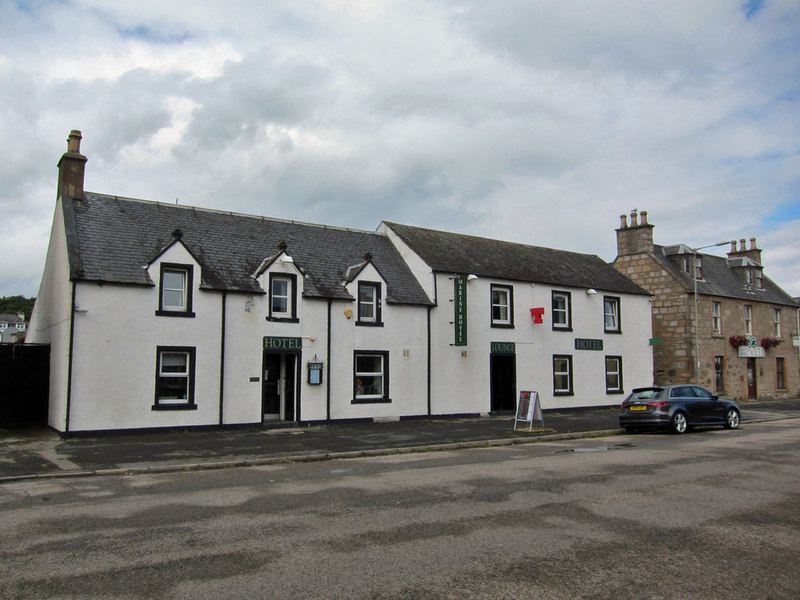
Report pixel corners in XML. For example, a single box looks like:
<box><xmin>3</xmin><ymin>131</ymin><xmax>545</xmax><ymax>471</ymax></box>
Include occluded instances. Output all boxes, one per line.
<box><xmin>64</xmin><ymin>192</ymin><xmax>431</xmax><ymax>305</ymax></box>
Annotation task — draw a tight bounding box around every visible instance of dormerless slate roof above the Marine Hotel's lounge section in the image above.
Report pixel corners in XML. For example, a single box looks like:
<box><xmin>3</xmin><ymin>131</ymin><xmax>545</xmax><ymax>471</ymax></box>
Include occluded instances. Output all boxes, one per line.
<box><xmin>385</xmin><ymin>222</ymin><xmax>650</xmax><ymax>296</ymax></box>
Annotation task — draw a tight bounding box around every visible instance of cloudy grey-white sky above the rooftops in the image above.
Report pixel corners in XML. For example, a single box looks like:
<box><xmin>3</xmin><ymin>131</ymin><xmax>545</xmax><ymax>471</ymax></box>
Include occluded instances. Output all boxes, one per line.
<box><xmin>0</xmin><ymin>0</ymin><xmax>800</xmax><ymax>296</ymax></box>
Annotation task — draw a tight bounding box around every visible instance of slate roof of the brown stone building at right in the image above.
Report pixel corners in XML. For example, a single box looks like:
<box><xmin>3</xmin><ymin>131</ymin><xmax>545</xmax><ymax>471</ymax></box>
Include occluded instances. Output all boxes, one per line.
<box><xmin>653</xmin><ymin>245</ymin><xmax>797</xmax><ymax>308</ymax></box>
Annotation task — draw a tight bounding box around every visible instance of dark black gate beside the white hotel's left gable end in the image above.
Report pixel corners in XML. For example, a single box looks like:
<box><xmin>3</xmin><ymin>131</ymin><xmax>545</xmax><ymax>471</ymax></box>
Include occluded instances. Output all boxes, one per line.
<box><xmin>0</xmin><ymin>344</ymin><xmax>50</xmax><ymax>427</ymax></box>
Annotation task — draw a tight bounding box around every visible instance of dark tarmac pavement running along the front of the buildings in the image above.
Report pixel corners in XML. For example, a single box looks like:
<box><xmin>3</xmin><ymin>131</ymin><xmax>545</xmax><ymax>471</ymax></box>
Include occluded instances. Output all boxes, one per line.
<box><xmin>0</xmin><ymin>399</ymin><xmax>800</xmax><ymax>483</ymax></box>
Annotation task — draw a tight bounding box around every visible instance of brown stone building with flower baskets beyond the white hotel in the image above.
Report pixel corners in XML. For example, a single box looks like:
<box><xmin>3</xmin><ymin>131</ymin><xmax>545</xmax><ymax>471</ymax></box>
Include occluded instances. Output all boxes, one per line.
<box><xmin>613</xmin><ymin>211</ymin><xmax>800</xmax><ymax>401</ymax></box>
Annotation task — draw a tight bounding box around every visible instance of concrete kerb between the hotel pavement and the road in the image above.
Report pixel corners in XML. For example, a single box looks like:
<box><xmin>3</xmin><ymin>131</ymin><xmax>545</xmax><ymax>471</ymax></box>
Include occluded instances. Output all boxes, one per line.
<box><xmin>0</xmin><ymin>429</ymin><xmax>624</xmax><ymax>484</ymax></box>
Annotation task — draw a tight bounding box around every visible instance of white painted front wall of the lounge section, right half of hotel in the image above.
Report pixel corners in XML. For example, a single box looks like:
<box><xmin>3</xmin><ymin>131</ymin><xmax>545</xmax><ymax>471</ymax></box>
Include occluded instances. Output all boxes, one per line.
<box><xmin>431</xmin><ymin>274</ymin><xmax>653</xmax><ymax>414</ymax></box>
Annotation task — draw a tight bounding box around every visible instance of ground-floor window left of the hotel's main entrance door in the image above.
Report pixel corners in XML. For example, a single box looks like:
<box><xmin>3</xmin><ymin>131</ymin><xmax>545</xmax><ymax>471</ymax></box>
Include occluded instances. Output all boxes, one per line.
<box><xmin>153</xmin><ymin>346</ymin><xmax>197</xmax><ymax>410</ymax></box>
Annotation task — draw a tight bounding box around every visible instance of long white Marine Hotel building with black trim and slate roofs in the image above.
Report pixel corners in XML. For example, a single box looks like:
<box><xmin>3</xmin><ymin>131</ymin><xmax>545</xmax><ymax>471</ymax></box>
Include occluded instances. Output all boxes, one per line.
<box><xmin>27</xmin><ymin>131</ymin><xmax>652</xmax><ymax>434</ymax></box>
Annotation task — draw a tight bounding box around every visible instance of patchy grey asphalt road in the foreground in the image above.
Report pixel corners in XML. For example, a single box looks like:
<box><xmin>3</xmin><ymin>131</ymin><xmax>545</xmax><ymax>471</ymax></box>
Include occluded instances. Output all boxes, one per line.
<box><xmin>0</xmin><ymin>419</ymin><xmax>800</xmax><ymax>600</ymax></box>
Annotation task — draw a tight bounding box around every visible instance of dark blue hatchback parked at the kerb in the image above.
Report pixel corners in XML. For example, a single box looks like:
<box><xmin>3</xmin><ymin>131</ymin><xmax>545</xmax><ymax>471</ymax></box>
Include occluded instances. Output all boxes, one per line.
<box><xmin>619</xmin><ymin>384</ymin><xmax>741</xmax><ymax>433</ymax></box>
